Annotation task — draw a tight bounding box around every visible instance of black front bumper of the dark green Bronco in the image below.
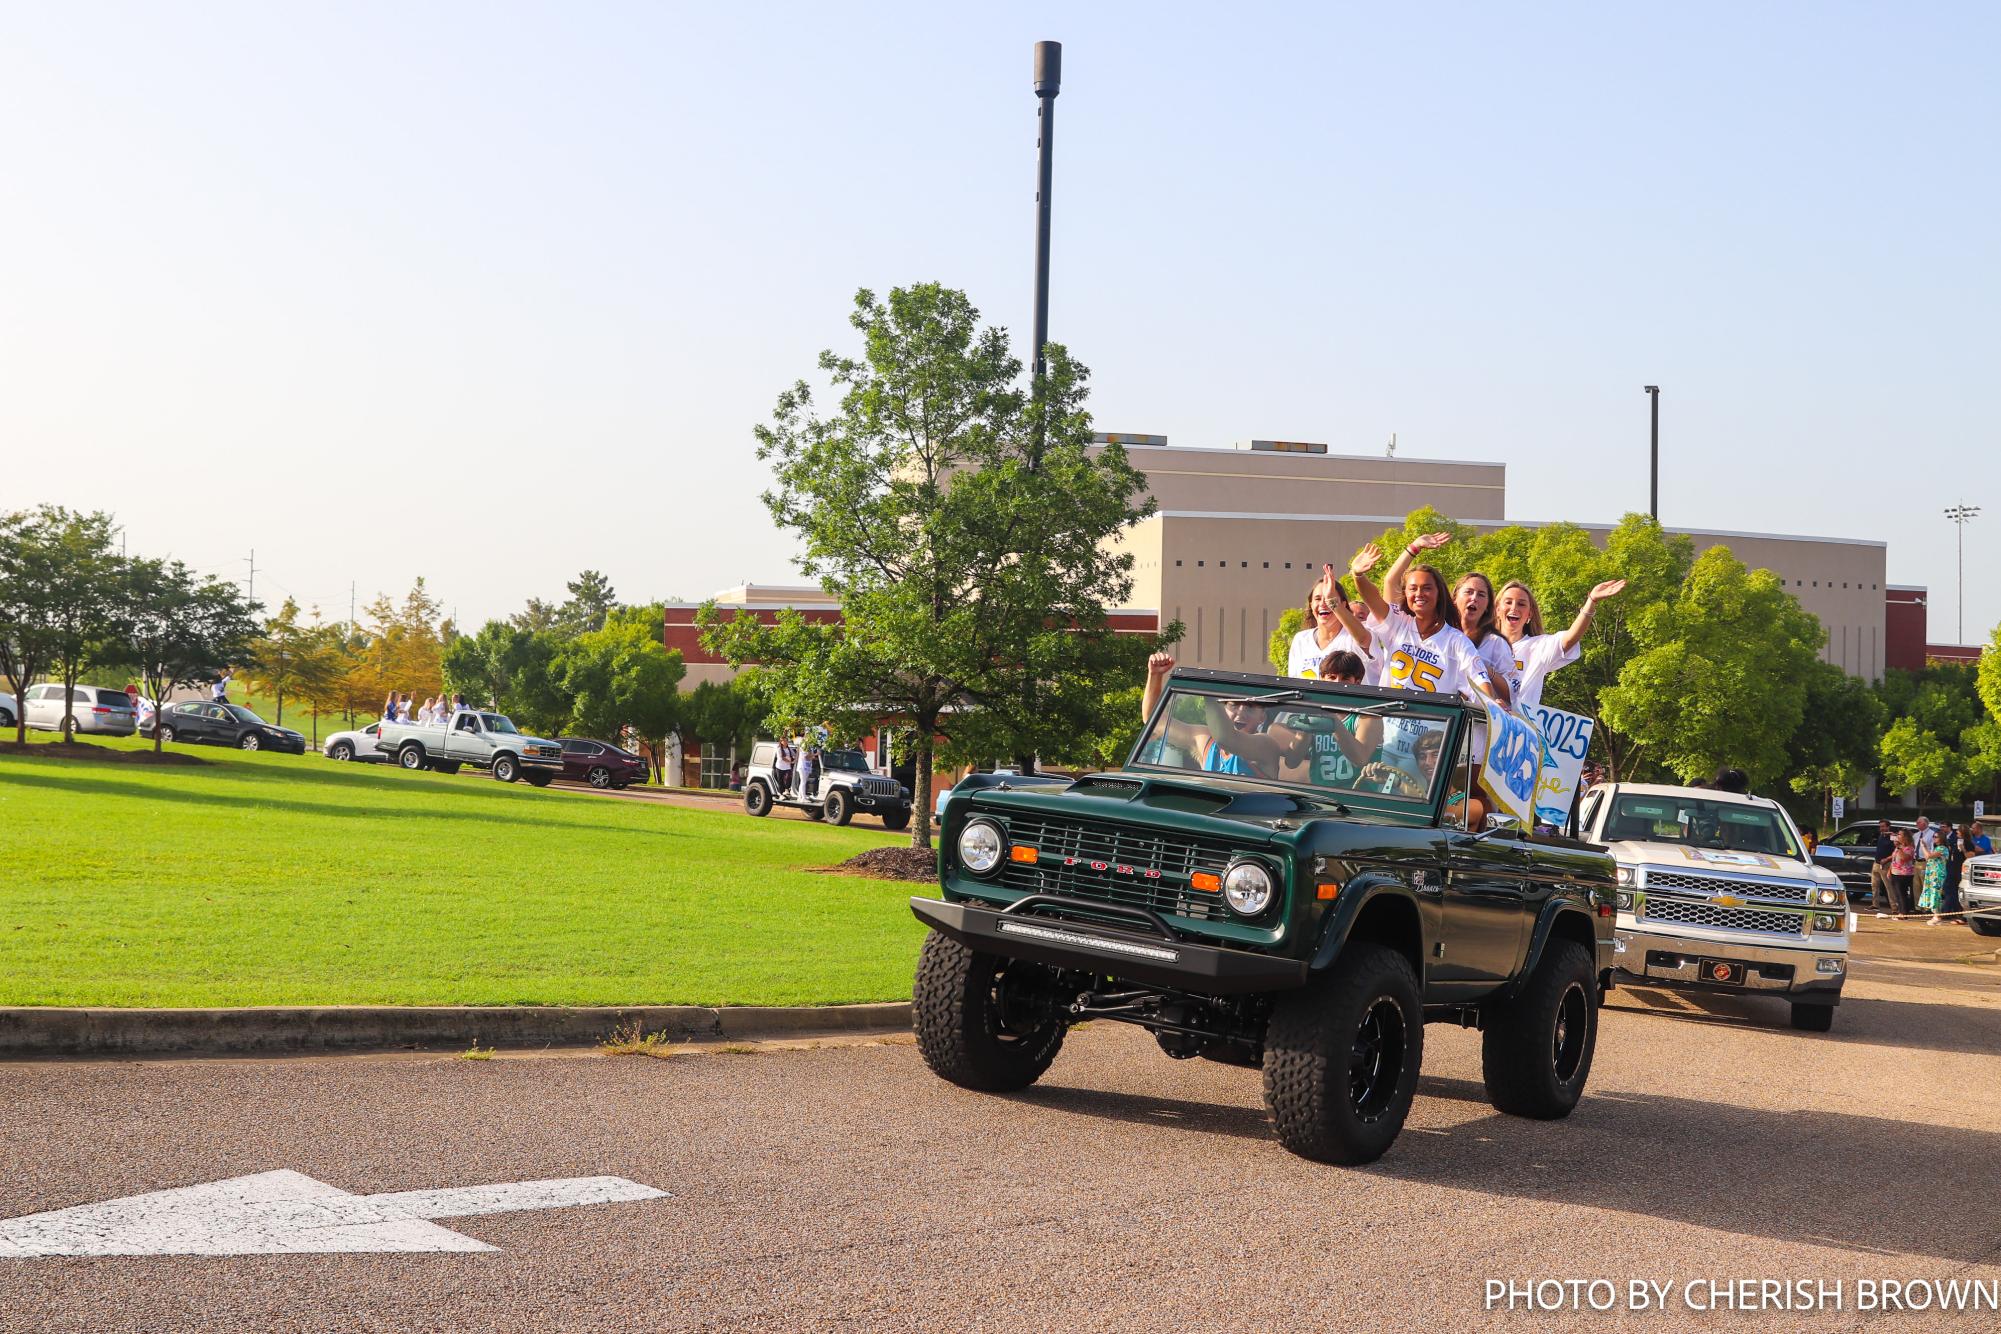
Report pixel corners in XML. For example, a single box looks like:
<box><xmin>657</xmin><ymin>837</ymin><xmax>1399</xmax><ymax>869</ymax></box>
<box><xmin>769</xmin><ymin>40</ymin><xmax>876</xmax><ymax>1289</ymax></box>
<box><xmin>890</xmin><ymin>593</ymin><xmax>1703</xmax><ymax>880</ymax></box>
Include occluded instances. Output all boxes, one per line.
<box><xmin>910</xmin><ymin>898</ymin><xmax>1309</xmax><ymax>996</ymax></box>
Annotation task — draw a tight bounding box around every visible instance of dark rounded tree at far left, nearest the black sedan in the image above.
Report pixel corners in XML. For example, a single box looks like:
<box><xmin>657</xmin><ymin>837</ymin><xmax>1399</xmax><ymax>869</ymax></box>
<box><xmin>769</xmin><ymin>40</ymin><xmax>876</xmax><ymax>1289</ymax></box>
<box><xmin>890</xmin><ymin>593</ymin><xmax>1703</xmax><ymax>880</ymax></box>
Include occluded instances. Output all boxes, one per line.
<box><xmin>120</xmin><ymin>560</ymin><xmax>258</xmax><ymax>752</ymax></box>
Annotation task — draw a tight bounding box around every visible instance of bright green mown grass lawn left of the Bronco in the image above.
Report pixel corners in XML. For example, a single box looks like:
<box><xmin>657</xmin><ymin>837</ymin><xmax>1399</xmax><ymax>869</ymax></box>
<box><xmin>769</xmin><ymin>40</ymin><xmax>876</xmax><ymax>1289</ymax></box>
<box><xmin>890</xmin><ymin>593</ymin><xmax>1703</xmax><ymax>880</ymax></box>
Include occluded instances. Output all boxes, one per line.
<box><xmin>0</xmin><ymin>736</ymin><xmax>922</xmax><ymax>1006</ymax></box>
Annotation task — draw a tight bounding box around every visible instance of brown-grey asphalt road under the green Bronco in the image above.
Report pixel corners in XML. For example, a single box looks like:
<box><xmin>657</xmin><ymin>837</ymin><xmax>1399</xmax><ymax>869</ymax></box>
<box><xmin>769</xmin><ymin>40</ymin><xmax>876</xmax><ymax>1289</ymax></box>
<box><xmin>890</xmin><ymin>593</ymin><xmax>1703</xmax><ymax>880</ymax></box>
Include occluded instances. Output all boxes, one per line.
<box><xmin>0</xmin><ymin>928</ymin><xmax>2001</xmax><ymax>1330</ymax></box>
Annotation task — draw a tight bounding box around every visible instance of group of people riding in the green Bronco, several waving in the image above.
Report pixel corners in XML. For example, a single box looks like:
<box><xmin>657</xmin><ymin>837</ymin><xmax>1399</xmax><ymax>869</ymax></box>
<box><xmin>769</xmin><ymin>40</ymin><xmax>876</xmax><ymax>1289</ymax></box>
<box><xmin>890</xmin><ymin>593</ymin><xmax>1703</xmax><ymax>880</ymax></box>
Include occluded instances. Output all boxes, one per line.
<box><xmin>1141</xmin><ymin>532</ymin><xmax>1625</xmax><ymax>828</ymax></box>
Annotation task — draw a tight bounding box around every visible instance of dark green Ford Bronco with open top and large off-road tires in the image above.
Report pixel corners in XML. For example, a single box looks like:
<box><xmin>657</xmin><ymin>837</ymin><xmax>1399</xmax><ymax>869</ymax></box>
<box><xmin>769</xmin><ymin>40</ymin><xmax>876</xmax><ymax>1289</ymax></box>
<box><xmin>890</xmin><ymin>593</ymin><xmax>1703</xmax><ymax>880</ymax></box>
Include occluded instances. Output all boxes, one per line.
<box><xmin>910</xmin><ymin>670</ymin><xmax>1617</xmax><ymax>1162</ymax></box>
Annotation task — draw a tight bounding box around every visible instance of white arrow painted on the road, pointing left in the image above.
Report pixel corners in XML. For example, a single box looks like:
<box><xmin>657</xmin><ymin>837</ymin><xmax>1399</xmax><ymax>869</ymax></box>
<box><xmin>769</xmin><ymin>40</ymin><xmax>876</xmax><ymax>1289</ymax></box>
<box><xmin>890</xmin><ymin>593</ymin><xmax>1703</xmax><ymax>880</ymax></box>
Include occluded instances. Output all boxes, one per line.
<box><xmin>0</xmin><ymin>1170</ymin><xmax>666</xmax><ymax>1258</ymax></box>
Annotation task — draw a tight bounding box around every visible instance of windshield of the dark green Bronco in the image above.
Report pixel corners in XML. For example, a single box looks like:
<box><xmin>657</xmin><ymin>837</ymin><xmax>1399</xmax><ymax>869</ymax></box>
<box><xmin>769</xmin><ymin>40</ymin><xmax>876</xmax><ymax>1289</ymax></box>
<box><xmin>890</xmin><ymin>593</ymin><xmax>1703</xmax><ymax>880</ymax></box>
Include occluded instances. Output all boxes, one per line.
<box><xmin>1133</xmin><ymin>690</ymin><xmax>1451</xmax><ymax>802</ymax></box>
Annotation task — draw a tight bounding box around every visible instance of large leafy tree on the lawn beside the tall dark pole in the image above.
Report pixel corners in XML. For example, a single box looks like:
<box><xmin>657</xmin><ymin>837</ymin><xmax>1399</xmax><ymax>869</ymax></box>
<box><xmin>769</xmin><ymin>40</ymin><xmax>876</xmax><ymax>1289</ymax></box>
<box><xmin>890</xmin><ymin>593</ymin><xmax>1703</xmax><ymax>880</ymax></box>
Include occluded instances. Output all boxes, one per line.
<box><xmin>698</xmin><ymin>284</ymin><xmax>1153</xmax><ymax>848</ymax></box>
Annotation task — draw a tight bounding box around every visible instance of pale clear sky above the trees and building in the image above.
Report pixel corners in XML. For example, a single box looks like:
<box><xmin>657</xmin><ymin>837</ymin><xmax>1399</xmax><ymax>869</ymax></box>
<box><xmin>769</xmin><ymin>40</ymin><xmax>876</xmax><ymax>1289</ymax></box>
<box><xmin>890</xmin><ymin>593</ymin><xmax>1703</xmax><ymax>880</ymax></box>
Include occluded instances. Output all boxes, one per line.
<box><xmin>0</xmin><ymin>0</ymin><xmax>2001</xmax><ymax>640</ymax></box>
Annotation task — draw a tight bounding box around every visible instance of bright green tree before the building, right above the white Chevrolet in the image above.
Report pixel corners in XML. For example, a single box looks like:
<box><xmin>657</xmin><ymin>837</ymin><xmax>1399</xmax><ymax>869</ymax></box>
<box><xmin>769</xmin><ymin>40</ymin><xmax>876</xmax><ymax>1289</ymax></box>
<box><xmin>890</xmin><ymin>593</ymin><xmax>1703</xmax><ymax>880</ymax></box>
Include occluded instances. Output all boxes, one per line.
<box><xmin>1599</xmin><ymin>546</ymin><xmax>1827</xmax><ymax>784</ymax></box>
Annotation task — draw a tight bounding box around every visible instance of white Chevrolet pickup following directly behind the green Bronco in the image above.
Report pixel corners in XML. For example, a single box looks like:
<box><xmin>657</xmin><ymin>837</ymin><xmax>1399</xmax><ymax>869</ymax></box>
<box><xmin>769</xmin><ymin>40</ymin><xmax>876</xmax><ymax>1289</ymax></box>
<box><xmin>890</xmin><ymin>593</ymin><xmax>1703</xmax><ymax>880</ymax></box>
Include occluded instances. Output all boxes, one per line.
<box><xmin>1577</xmin><ymin>784</ymin><xmax>1855</xmax><ymax>1032</ymax></box>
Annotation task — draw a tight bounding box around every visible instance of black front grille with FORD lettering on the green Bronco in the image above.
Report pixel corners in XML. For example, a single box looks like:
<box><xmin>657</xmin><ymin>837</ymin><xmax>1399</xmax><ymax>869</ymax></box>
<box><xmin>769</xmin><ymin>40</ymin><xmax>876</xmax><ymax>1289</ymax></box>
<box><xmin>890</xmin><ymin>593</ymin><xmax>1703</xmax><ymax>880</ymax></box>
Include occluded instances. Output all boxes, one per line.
<box><xmin>998</xmin><ymin>816</ymin><xmax>1243</xmax><ymax>918</ymax></box>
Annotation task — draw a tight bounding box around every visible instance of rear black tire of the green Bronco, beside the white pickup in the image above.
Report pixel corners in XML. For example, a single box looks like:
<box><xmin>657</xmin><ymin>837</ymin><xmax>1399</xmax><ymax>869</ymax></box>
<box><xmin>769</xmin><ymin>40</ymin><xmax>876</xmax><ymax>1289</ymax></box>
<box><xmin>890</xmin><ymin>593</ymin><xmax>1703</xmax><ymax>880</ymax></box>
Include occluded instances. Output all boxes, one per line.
<box><xmin>1481</xmin><ymin>938</ymin><xmax>1599</xmax><ymax>1120</ymax></box>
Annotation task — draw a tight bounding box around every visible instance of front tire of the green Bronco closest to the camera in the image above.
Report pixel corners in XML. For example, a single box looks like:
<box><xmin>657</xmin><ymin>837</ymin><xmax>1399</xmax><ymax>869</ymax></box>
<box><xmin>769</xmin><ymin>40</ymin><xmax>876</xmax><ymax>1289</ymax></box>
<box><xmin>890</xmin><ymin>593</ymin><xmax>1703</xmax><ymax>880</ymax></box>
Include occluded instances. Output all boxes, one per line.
<box><xmin>1265</xmin><ymin>940</ymin><xmax>1425</xmax><ymax>1164</ymax></box>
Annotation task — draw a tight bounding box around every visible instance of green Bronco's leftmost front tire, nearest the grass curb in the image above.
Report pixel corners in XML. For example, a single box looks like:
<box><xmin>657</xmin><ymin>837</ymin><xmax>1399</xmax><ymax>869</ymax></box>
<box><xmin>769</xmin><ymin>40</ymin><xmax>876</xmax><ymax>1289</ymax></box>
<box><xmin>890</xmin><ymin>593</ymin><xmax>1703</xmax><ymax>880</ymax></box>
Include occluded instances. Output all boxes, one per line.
<box><xmin>910</xmin><ymin>932</ymin><xmax>1067</xmax><ymax>1094</ymax></box>
